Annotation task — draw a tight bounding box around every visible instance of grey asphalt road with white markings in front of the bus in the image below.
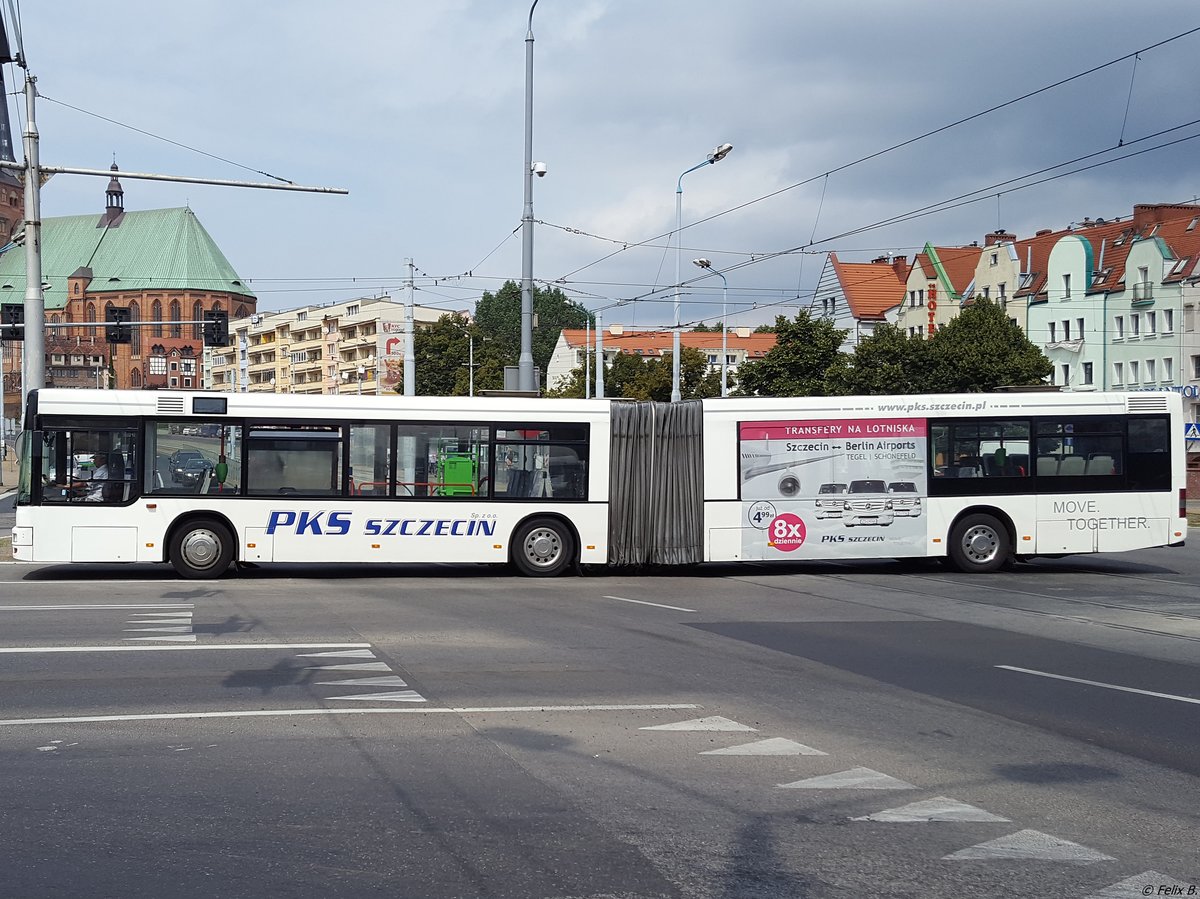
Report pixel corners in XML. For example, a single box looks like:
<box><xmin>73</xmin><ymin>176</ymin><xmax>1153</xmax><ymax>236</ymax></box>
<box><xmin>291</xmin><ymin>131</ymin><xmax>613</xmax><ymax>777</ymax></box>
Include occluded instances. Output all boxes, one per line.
<box><xmin>0</xmin><ymin>545</ymin><xmax>1200</xmax><ymax>899</ymax></box>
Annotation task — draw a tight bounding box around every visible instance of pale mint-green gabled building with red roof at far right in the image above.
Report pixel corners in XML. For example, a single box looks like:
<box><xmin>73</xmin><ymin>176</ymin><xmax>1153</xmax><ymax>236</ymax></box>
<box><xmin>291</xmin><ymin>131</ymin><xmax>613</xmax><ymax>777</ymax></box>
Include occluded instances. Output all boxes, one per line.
<box><xmin>1026</xmin><ymin>204</ymin><xmax>1200</xmax><ymax>432</ymax></box>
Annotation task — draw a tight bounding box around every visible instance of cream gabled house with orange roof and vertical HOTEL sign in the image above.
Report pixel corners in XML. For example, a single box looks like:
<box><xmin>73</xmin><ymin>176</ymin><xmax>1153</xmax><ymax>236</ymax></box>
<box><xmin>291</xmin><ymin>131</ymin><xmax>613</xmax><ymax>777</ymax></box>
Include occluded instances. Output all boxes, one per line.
<box><xmin>896</xmin><ymin>244</ymin><xmax>983</xmax><ymax>337</ymax></box>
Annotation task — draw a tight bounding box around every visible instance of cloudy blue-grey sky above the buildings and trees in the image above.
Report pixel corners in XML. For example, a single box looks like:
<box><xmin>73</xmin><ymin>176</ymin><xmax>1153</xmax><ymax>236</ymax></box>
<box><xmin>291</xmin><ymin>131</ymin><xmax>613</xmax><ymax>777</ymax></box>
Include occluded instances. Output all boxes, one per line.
<box><xmin>5</xmin><ymin>0</ymin><xmax>1200</xmax><ymax>326</ymax></box>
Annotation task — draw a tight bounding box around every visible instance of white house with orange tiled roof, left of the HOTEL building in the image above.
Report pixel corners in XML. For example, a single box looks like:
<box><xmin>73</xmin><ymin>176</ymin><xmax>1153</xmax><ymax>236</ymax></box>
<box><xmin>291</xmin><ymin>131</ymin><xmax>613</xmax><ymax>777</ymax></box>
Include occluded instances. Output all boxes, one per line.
<box><xmin>812</xmin><ymin>253</ymin><xmax>910</xmax><ymax>353</ymax></box>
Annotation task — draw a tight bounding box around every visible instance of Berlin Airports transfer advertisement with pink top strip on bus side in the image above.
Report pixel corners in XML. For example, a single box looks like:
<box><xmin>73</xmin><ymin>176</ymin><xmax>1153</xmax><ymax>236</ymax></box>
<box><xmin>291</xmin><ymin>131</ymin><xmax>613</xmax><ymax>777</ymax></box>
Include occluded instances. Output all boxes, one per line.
<box><xmin>739</xmin><ymin>418</ymin><xmax>929</xmax><ymax>559</ymax></box>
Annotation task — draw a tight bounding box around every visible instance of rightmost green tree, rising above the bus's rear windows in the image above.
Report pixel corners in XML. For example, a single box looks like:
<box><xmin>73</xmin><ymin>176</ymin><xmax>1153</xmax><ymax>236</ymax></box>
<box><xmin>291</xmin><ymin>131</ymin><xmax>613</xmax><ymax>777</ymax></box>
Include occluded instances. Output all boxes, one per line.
<box><xmin>925</xmin><ymin>299</ymin><xmax>1051</xmax><ymax>394</ymax></box>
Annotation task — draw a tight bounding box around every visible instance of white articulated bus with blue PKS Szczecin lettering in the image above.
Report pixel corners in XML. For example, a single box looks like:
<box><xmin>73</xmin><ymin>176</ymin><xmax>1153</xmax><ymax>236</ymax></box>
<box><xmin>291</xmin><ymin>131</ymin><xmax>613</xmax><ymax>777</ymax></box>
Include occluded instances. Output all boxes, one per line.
<box><xmin>13</xmin><ymin>389</ymin><xmax>1187</xmax><ymax>577</ymax></box>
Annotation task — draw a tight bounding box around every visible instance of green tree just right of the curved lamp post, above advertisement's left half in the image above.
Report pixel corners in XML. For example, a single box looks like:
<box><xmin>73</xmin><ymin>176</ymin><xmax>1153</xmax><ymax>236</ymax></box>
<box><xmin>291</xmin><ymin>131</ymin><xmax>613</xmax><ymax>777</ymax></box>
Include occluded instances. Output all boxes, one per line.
<box><xmin>738</xmin><ymin>310</ymin><xmax>846</xmax><ymax>396</ymax></box>
